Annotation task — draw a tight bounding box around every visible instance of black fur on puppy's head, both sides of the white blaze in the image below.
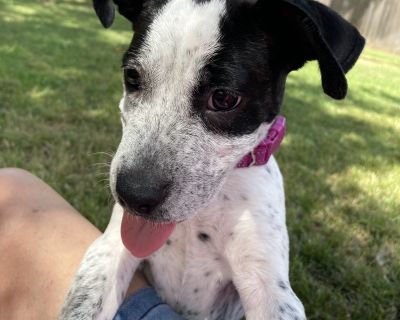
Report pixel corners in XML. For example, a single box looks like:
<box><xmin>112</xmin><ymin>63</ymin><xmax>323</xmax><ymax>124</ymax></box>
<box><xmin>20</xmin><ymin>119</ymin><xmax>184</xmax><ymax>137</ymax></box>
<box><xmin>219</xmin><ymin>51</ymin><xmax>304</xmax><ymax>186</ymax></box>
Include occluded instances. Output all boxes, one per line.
<box><xmin>119</xmin><ymin>0</ymin><xmax>364</xmax><ymax>136</ymax></box>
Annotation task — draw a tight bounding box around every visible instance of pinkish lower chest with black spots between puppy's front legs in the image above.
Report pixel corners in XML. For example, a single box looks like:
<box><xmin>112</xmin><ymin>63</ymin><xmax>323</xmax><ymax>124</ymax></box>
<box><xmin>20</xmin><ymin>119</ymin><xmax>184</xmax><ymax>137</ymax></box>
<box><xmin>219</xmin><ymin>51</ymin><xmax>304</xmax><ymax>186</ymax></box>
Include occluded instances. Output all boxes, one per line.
<box><xmin>144</xmin><ymin>207</ymin><xmax>238</xmax><ymax>319</ymax></box>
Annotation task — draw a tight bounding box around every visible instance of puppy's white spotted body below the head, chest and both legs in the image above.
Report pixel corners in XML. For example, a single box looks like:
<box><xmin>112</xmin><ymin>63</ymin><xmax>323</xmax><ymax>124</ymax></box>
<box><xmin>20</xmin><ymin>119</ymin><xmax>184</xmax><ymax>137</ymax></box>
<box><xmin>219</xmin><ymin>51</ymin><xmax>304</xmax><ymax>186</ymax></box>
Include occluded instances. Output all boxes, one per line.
<box><xmin>60</xmin><ymin>158</ymin><xmax>305</xmax><ymax>320</ymax></box>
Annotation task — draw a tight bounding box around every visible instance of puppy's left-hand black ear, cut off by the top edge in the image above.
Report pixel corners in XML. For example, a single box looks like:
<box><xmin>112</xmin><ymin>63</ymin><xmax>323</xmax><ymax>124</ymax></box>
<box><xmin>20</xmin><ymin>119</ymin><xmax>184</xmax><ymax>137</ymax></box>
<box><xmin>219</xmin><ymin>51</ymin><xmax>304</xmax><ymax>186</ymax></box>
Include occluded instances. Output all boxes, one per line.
<box><xmin>93</xmin><ymin>0</ymin><xmax>143</xmax><ymax>28</ymax></box>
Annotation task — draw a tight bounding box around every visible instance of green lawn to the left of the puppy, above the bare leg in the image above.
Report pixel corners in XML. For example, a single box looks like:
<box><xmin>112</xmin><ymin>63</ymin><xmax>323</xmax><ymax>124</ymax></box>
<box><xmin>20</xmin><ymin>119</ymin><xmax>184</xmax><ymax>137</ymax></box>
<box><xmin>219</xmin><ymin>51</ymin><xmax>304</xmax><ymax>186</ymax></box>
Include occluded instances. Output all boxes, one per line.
<box><xmin>0</xmin><ymin>1</ymin><xmax>131</xmax><ymax>229</ymax></box>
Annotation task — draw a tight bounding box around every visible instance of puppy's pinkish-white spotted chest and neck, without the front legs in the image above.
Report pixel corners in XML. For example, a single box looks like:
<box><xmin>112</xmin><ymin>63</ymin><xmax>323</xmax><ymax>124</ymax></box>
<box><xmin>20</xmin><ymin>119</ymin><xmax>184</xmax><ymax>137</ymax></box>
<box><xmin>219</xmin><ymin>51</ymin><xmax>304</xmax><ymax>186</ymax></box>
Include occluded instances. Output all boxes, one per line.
<box><xmin>144</xmin><ymin>161</ymin><xmax>284</xmax><ymax>320</ymax></box>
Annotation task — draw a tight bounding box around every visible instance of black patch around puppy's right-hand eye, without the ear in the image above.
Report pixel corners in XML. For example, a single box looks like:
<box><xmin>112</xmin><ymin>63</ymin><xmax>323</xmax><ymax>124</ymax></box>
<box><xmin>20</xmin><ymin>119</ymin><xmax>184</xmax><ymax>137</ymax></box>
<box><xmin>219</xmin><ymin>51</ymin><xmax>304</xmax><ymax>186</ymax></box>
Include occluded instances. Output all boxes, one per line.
<box><xmin>193</xmin><ymin>5</ymin><xmax>288</xmax><ymax>135</ymax></box>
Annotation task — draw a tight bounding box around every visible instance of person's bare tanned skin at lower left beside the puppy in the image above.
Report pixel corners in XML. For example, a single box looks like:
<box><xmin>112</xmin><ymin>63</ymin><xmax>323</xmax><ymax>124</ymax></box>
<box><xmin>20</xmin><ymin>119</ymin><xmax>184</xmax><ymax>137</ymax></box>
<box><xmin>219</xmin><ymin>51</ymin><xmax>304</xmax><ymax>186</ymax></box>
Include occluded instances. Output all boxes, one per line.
<box><xmin>0</xmin><ymin>169</ymin><xmax>148</xmax><ymax>320</ymax></box>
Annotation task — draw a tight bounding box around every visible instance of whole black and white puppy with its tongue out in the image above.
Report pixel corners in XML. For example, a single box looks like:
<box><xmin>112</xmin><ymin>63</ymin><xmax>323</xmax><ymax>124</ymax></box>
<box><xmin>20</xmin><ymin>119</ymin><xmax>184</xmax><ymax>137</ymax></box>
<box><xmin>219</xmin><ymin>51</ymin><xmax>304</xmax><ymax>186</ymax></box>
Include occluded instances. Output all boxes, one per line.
<box><xmin>60</xmin><ymin>0</ymin><xmax>364</xmax><ymax>320</ymax></box>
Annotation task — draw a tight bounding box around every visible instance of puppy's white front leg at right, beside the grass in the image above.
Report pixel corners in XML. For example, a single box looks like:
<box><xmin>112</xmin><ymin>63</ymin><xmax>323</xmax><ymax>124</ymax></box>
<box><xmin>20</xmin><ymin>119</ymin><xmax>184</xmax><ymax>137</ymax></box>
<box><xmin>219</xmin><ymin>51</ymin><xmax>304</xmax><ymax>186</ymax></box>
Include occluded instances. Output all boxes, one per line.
<box><xmin>226</xmin><ymin>212</ymin><xmax>306</xmax><ymax>320</ymax></box>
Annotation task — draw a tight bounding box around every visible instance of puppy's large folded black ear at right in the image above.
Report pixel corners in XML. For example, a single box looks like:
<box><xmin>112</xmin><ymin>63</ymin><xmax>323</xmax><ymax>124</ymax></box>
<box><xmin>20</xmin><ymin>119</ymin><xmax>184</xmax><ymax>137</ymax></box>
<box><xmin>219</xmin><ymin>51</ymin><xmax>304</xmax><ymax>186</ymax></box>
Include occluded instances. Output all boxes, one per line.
<box><xmin>282</xmin><ymin>0</ymin><xmax>365</xmax><ymax>99</ymax></box>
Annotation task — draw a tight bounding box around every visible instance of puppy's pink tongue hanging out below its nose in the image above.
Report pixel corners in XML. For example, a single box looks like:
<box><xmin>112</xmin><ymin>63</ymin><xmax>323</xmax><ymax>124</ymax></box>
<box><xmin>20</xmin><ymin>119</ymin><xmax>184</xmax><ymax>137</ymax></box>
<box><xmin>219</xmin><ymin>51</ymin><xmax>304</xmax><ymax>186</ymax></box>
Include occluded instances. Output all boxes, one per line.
<box><xmin>121</xmin><ymin>211</ymin><xmax>175</xmax><ymax>258</ymax></box>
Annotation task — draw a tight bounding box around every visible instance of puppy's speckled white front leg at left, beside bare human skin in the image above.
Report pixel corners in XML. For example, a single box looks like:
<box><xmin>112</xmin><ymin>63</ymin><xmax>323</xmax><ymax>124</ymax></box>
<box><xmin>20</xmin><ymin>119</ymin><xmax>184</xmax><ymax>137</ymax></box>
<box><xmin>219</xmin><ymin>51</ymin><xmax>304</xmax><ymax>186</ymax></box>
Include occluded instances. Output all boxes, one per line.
<box><xmin>59</xmin><ymin>205</ymin><xmax>140</xmax><ymax>320</ymax></box>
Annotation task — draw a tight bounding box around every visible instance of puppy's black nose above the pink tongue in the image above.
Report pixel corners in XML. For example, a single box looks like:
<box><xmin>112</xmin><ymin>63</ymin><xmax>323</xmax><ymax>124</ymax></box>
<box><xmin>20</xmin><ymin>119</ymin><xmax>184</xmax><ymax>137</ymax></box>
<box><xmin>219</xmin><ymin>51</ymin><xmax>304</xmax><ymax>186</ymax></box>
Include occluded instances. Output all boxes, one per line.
<box><xmin>115</xmin><ymin>170</ymin><xmax>169</xmax><ymax>216</ymax></box>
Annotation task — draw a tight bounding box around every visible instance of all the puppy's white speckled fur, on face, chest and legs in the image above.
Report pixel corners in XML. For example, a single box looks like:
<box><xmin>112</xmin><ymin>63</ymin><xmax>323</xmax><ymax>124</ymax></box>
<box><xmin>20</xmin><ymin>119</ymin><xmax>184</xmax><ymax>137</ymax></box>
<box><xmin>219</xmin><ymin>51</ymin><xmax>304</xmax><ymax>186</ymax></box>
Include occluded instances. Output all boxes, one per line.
<box><xmin>60</xmin><ymin>0</ymin><xmax>305</xmax><ymax>320</ymax></box>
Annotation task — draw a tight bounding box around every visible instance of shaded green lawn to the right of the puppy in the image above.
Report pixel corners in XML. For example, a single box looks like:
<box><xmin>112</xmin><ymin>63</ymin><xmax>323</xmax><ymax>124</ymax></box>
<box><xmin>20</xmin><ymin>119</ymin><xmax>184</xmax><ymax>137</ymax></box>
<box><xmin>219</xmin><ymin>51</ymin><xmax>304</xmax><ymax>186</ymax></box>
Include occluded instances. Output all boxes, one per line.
<box><xmin>278</xmin><ymin>77</ymin><xmax>400</xmax><ymax>320</ymax></box>
